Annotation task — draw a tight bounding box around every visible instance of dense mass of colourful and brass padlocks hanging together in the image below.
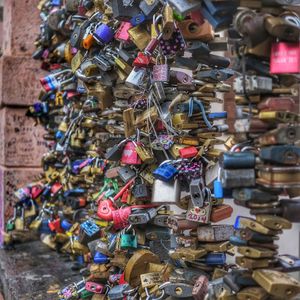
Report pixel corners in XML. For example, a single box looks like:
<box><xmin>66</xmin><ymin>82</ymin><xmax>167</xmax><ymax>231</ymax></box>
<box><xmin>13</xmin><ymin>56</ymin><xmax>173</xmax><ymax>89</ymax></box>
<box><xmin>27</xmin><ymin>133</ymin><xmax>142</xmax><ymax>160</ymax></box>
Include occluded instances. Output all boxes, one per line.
<box><xmin>2</xmin><ymin>0</ymin><xmax>300</xmax><ymax>300</ymax></box>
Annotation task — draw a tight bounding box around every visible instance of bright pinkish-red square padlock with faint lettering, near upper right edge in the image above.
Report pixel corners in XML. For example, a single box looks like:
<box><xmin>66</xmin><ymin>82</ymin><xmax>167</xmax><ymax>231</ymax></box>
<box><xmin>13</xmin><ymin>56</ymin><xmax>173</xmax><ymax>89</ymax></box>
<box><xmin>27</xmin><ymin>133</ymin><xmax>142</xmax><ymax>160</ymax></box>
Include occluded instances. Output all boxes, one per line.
<box><xmin>270</xmin><ymin>42</ymin><xmax>300</xmax><ymax>74</ymax></box>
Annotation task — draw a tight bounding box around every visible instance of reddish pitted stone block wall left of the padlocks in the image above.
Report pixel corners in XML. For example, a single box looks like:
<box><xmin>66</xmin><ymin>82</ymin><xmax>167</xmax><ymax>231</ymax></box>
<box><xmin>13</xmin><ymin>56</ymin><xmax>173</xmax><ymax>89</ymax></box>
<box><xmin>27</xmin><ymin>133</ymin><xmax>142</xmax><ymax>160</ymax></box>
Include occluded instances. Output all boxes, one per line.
<box><xmin>0</xmin><ymin>0</ymin><xmax>46</xmax><ymax>243</ymax></box>
